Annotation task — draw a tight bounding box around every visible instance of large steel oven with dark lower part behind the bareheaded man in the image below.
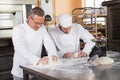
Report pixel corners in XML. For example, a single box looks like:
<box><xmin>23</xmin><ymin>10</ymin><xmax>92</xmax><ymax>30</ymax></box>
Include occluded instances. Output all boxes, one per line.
<box><xmin>0</xmin><ymin>0</ymin><xmax>35</xmax><ymax>80</ymax></box>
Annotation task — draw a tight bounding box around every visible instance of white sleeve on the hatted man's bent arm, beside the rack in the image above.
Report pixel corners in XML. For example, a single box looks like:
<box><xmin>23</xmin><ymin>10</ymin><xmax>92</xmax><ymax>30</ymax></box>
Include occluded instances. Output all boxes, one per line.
<box><xmin>79</xmin><ymin>25</ymin><xmax>95</xmax><ymax>55</ymax></box>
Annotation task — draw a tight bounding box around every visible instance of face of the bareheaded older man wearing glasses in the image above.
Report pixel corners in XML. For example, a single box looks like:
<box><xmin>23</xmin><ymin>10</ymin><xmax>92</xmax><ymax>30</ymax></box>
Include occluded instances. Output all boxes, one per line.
<box><xmin>28</xmin><ymin>15</ymin><xmax>44</xmax><ymax>31</ymax></box>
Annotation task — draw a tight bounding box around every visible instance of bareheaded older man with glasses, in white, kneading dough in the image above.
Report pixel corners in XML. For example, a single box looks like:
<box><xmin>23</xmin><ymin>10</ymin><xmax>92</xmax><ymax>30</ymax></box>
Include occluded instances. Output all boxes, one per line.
<box><xmin>11</xmin><ymin>7</ymin><xmax>58</xmax><ymax>80</ymax></box>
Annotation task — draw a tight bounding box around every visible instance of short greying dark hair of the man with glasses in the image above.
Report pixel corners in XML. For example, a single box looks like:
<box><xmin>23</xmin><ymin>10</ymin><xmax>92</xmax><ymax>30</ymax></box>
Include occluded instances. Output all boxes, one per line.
<box><xmin>29</xmin><ymin>7</ymin><xmax>45</xmax><ymax>17</ymax></box>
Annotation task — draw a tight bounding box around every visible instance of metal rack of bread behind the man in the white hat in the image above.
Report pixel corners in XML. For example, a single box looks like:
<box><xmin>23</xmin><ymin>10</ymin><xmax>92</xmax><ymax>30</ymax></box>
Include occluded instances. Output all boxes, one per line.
<box><xmin>72</xmin><ymin>7</ymin><xmax>107</xmax><ymax>46</ymax></box>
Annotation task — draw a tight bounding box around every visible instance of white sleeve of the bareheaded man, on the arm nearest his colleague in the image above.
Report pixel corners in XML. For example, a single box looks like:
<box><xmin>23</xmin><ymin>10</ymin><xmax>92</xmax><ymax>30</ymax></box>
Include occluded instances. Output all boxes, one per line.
<box><xmin>43</xmin><ymin>27</ymin><xmax>58</xmax><ymax>56</ymax></box>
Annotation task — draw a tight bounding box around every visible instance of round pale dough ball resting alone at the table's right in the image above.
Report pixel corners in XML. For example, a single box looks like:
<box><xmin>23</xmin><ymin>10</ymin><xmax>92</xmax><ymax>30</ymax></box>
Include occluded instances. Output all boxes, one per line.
<box><xmin>96</xmin><ymin>57</ymin><xmax>114</xmax><ymax>65</ymax></box>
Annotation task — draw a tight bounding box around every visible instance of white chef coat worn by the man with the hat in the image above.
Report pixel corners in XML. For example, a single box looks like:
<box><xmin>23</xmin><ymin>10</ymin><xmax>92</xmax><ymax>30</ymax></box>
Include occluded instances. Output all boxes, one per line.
<box><xmin>49</xmin><ymin>23</ymin><xmax>95</xmax><ymax>57</ymax></box>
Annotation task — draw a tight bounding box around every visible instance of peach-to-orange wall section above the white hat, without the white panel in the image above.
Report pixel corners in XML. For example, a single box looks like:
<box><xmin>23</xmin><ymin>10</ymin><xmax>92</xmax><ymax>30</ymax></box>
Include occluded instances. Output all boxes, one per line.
<box><xmin>55</xmin><ymin>0</ymin><xmax>82</xmax><ymax>16</ymax></box>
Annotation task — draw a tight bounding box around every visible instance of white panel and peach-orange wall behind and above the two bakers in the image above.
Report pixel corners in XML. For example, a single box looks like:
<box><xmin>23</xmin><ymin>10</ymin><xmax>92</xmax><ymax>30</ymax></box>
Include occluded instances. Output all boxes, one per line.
<box><xmin>39</xmin><ymin>0</ymin><xmax>82</xmax><ymax>24</ymax></box>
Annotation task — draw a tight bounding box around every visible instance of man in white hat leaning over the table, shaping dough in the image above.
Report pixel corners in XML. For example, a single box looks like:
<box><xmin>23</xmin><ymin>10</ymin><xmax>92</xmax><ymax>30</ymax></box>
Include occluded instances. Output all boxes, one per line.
<box><xmin>49</xmin><ymin>14</ymin><xmax>95</xmax><ymax>58</ymax></box>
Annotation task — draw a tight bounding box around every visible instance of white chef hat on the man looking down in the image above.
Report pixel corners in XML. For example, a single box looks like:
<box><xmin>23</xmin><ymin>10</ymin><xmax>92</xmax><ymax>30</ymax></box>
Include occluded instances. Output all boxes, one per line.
<box><xmin>58</xmin><ymin>14</ymin><xmax>72</xmax><ymax>28</ymax></box>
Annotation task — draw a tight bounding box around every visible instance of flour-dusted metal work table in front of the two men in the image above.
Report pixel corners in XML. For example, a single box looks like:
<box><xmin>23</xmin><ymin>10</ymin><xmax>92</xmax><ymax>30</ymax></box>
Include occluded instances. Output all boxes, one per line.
<box><xmin>21</xmin><ymin>52</ymin><xmax>120</xmax><ymax>80</ymax></box>
